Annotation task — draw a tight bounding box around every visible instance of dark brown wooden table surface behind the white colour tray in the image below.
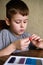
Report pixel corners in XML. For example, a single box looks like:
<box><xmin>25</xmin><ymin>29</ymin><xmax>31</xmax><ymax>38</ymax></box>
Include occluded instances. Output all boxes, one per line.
<box><xmin>0</xmin><ymin>50</ymin><xmax>43</xmax><ymax>65</ymax></box>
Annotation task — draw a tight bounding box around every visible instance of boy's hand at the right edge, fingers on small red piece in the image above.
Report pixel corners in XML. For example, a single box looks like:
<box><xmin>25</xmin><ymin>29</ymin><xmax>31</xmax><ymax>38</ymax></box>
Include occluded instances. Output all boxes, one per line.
<box><xmin>30</xmin><ymin>34</ymin><xmax>43</xmax><ymax>49</ymax></box>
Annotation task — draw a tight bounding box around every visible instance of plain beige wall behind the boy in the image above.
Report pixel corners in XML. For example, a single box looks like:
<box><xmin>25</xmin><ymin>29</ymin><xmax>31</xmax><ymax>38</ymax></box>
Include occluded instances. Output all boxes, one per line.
<box><xmin>0</xmin><ymin>0</ymin><xmax>43</xmax><ymax>38</ymax></box>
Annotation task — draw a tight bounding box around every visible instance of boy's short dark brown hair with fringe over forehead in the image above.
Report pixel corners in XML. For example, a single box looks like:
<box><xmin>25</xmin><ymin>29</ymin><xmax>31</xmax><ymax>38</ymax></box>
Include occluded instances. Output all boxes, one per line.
<box><xmin>6</xmin><ymin>0</ymin><xmax>29</xmax><ymax>19</ymax></box>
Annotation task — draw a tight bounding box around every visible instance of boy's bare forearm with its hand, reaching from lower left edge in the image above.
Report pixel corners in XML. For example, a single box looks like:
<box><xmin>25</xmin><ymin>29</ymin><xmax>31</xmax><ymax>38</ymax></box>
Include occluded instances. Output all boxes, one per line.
<box><xmin>0</xmin><ymin>38</ymin><xmax>30</xmax><ymax>56</ymax></box>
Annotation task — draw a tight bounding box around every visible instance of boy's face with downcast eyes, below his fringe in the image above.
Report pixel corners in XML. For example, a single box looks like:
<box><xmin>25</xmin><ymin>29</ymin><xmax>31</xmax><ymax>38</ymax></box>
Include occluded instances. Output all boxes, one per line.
<box><xmin>10</xmin><ymin>13</ymin><xmax>28</xmax><ymax>35</ymax></box>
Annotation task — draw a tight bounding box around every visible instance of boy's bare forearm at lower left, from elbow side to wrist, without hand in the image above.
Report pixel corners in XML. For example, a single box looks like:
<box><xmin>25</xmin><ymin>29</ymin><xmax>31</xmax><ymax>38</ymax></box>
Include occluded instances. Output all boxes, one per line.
<box><xmin>0</xmin><ymin>43</ymin><xmax>16</xmax><ymax>56</ymax></box>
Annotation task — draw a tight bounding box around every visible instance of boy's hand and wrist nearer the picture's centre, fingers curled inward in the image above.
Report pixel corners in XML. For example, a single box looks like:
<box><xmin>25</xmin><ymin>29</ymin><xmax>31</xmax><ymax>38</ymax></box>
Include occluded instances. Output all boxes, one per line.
<box><xmin>14</xmin><ymin>38</ymin><xmax>30</xmax><ymax>50</ymax></box>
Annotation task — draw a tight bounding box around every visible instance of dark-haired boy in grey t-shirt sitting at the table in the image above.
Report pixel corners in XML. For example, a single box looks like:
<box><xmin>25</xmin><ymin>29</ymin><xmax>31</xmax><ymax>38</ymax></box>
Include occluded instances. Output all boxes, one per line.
<box><xmin>0</xmin><ymin>0</ymin><xmax>43</xmax><ymax>56</ymax></box>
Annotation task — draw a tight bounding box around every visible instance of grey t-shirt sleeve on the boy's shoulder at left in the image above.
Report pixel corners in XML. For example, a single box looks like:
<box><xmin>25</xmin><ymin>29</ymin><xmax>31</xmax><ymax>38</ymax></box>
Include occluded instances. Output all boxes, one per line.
<box><xmin>0</xmin><ymin>29</ymin><xmax>9</xmax><ymax>50</ymax></box>
